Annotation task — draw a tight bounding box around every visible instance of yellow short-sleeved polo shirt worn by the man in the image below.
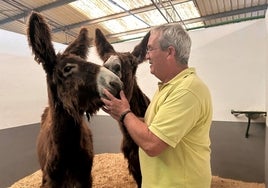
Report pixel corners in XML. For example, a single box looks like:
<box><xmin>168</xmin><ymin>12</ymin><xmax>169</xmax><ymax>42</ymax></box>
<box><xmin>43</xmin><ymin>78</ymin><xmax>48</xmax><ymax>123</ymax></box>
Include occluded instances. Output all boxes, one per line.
<box><xmin>139</xmin><ymin>68</ymin><xmax>212</xmax><ymax>188</ymax></box>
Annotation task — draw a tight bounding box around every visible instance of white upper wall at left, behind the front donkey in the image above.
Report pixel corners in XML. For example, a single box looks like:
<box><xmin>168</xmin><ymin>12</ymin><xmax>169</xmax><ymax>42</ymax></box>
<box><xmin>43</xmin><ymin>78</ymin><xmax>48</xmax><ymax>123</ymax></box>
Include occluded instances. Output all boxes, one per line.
<box><xmin>0</xmin><ymin>30</ymin><xmax>65</xmax><ymax>129</ymax></box>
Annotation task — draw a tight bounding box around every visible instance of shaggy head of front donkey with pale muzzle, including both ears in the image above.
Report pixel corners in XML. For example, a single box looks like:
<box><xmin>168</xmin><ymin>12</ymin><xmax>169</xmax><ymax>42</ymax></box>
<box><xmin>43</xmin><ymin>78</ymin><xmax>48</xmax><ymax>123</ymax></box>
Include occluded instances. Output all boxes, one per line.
<box><xmin>28</xmin><ymin>12</ymin><xmax>122</xmax><ymax>117</ymax></box>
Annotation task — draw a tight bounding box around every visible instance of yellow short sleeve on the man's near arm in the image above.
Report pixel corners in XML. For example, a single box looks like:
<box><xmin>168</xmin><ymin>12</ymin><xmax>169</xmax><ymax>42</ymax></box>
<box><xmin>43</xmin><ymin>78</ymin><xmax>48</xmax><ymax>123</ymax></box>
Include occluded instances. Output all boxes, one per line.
<box><xmin>149</xmin><ymin>89</ymin><xmax>200</xmax><ymax>147</ymax></box>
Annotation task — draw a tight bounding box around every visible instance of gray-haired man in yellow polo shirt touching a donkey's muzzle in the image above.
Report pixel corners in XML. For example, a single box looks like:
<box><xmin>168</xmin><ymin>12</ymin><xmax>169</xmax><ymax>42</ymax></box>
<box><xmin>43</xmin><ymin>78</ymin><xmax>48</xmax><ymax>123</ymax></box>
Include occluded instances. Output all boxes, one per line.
<box><xmin>102</xmin><ymin>24</ymin><xmax>212</xmax><ymax>188</ymax></box>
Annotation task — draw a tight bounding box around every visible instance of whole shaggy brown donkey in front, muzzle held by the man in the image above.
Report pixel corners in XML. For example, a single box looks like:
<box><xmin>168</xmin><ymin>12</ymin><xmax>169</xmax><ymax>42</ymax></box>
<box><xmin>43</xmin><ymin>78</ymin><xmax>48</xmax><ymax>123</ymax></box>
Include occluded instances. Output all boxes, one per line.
<box><xmin>27</xmin><ymin>12</ymin><xmax>122</xmax><ymax>188</ymax></box>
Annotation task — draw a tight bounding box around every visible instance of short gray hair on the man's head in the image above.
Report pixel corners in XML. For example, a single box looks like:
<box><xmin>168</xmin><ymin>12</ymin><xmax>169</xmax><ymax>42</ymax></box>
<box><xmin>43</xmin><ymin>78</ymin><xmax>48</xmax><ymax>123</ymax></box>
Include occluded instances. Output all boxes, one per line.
<box><xmin>151</xmin><ymin>23</ymin><xmax>192</xmax><ymax>64</ymax></box>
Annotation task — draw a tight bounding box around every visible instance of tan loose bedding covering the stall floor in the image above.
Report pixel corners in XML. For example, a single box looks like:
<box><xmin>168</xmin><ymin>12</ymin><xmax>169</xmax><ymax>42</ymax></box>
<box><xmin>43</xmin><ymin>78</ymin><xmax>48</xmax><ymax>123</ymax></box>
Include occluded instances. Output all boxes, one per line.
<box><xmin>10</xmin><ymin>153</ymin><xmax>265</xmax><ymax>188</ymax></box>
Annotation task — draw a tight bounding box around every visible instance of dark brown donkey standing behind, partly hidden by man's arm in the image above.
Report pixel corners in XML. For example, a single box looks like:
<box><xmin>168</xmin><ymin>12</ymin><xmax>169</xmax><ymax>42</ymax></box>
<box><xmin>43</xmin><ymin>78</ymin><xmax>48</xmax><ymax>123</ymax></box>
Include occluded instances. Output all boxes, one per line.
<box><xmin>95</xmin><ymin>29</ymin><xmax>150</xmax><ymax>187</ymax></box>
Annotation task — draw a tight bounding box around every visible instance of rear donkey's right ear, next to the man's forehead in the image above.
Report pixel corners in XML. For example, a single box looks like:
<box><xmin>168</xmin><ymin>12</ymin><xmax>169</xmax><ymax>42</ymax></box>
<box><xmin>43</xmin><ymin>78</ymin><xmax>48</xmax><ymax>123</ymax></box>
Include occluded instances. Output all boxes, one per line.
<box><xmin>132</xmin><ymin>32</ymin><xmax>150</xmax><ymax>63</ymax></box>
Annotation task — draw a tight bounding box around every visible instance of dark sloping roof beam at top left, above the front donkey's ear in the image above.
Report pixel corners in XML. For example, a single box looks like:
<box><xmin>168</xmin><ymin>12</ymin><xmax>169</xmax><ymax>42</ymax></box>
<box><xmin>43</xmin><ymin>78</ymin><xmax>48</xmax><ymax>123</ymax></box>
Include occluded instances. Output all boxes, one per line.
<box><xmin>0</xmin><ymin>0</ymin><xmax>76</xmax><ymax>25</ymax></box>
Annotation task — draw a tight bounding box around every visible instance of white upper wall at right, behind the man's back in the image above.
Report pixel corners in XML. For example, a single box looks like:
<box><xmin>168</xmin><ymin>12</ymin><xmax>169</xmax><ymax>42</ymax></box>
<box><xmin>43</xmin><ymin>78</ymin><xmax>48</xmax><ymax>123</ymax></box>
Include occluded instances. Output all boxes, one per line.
<box><xmin>191</xmin><ymin>19</ymin><xmax>267</xmax><ymax>121</ymax></box>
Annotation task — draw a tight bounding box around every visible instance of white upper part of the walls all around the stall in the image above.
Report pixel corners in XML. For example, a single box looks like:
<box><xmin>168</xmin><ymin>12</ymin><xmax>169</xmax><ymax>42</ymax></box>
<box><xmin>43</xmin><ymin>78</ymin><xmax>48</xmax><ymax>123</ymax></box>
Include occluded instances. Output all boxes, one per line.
<box><xmin>0</xmin><ymin>19</ymin><xmax>267</xmax><ymax>129</ymax></box>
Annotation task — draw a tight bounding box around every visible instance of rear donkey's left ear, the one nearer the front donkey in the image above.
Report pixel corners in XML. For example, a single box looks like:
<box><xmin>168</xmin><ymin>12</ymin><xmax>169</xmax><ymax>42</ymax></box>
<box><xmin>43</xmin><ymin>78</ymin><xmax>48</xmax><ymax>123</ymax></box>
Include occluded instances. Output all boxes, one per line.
<box><xmin>95</xmin><ymin>29</ymin><xmax>116</xmax><ymax>61</ymax></box>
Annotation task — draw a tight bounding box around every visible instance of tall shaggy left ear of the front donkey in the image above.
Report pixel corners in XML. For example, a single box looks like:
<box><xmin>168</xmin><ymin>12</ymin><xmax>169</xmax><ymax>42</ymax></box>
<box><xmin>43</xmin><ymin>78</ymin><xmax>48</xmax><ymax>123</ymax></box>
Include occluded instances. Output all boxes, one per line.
<box><xmin>27</xmin><ymin>12</ymin><xmax>56</xmax><ymax>74</ymax></box>
